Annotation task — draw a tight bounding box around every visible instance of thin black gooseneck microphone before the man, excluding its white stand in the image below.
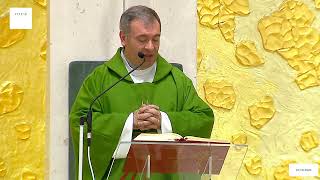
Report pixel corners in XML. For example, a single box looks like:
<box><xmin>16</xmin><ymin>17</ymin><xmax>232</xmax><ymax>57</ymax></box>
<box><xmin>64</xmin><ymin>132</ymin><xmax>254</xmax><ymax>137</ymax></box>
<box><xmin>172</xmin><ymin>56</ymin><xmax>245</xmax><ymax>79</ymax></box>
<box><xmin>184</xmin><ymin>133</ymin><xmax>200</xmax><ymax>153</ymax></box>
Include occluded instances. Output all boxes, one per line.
<box><xmin>87</xmin><ymin>52</ymin><xmax>146</xmax><ymax>146</ymax></box>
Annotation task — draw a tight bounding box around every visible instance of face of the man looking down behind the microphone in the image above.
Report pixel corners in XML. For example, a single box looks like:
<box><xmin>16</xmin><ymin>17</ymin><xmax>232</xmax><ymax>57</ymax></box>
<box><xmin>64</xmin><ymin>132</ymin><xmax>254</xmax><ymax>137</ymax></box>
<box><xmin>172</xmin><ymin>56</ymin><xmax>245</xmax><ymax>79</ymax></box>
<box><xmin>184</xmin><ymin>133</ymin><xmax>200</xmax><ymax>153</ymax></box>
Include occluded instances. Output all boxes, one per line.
<box><xmin>120</xmin><ymin>19</ymin><xmax>160</xmax><ymax>69</ymax></box>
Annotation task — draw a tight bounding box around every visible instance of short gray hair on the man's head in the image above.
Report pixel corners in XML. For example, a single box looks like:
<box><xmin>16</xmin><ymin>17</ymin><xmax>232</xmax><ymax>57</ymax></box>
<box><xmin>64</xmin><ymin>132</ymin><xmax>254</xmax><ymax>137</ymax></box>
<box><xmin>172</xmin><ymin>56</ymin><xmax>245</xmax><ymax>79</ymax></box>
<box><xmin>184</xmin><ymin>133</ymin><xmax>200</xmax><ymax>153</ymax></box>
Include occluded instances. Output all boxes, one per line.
<box><xmin>120</xmin><ymin>5</ymin><xmax>161</xmax><ymax>34</ymax></box>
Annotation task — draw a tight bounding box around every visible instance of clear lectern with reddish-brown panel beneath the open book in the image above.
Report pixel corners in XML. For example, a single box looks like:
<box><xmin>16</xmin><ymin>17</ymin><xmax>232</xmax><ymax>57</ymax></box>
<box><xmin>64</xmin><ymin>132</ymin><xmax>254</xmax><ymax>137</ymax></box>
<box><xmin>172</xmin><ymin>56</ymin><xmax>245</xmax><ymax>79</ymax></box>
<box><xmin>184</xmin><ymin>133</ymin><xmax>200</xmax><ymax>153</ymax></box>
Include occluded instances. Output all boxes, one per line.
<box><xmin>108</xmin><ymin>141</ymin><xmax>248</xmax><ymax>180</ymax></box>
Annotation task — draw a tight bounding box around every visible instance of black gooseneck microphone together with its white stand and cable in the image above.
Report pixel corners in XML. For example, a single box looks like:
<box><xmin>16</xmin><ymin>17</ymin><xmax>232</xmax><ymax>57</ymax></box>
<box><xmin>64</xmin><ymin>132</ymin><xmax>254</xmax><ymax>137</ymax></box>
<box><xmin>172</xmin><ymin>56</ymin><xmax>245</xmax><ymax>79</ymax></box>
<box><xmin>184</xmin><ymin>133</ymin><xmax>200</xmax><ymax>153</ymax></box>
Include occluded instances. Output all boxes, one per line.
<box><xmin>78</xmin><ymin>52</ymin><xmax>146</xmax><ymax>180</ymax></box>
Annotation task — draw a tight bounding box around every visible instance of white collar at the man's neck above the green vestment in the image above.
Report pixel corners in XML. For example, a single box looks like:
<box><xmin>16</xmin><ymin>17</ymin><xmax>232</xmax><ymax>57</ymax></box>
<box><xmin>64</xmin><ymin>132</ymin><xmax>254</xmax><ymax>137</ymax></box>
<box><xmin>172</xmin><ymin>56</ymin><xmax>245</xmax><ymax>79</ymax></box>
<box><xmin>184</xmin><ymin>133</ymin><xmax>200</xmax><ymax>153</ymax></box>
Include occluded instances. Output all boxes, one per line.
<box><xmin>121</xmin><ymin>49</ymin><xmax>157</xmax><ymax>83</ymax></box>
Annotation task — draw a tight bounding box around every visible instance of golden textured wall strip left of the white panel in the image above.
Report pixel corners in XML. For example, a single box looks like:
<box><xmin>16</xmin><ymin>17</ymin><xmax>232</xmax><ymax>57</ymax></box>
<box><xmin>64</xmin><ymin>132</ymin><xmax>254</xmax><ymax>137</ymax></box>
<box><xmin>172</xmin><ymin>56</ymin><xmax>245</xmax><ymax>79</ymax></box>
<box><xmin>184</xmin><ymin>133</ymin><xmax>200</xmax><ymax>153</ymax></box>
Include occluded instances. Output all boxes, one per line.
<box><xmin>0</xmin><ymin>0</ymin><xmax>47</xmax><ymax>180</ymax></box>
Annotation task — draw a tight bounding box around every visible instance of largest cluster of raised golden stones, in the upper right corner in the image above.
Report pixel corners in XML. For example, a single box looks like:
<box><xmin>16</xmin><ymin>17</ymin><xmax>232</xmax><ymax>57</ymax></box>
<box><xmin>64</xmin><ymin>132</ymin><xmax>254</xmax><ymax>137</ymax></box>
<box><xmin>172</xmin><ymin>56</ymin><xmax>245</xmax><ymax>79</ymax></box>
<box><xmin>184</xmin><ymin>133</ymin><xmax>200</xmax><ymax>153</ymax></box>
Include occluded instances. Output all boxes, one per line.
<box><xmin>258</xmin><ymin>0</ymin><xmax>320</xmax><ymax>90</ymax></box>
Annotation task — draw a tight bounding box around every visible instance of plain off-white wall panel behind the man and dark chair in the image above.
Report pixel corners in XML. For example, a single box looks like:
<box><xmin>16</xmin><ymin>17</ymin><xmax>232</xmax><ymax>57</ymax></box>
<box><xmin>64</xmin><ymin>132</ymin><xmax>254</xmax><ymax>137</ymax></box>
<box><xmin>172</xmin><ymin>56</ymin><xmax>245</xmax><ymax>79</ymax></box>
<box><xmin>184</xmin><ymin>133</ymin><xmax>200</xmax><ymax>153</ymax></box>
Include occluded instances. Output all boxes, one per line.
<box><xmin>48</xmin><ymin>0</ymin><xmax>196</xmax><ymax>179</ymax></box>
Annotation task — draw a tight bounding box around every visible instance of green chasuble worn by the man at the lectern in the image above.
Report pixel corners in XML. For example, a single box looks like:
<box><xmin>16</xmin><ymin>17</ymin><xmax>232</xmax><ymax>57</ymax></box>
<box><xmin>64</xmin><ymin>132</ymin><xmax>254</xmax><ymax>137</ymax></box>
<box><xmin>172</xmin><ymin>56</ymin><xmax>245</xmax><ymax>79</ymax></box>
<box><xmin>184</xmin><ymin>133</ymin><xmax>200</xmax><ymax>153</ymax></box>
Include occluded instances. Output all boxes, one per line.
<box><xmin>70</xmin><ymin>48</ymin><xmax>214</xmax><ymax>179</ymax></box>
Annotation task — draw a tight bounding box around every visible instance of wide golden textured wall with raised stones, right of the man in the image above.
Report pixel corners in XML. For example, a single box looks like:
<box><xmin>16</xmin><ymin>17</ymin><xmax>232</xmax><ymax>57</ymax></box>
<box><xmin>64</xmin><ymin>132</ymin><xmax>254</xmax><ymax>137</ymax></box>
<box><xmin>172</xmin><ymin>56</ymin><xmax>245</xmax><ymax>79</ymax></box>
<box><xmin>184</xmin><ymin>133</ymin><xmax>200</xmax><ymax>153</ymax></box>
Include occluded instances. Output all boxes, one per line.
<box><xmin>197</xmin><ymin>0</ymin><xmax>320</xmax><ymax>180</ymax></box>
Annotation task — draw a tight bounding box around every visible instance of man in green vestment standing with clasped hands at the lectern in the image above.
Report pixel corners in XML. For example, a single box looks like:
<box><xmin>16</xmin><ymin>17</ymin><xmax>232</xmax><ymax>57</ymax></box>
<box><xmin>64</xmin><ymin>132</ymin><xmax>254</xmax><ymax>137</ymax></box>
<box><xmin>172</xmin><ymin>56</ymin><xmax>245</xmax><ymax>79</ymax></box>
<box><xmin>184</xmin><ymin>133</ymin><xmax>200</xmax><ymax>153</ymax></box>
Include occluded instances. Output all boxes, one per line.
<box><xmin>70</xmin><ymin>6</ymin><xmax>214</xmax><ymax>179</ymax></box>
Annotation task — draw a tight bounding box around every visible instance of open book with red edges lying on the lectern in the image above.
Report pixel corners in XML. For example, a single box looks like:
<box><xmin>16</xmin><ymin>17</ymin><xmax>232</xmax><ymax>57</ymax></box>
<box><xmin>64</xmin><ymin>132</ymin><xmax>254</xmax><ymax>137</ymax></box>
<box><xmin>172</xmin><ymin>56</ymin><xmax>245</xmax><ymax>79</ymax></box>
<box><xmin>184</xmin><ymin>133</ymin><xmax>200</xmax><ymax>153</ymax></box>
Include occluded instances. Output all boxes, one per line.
<box><xmin>134</xmin><ymin>133</ymin><xmax>230</xmax><ymax>144</ymax></box>
